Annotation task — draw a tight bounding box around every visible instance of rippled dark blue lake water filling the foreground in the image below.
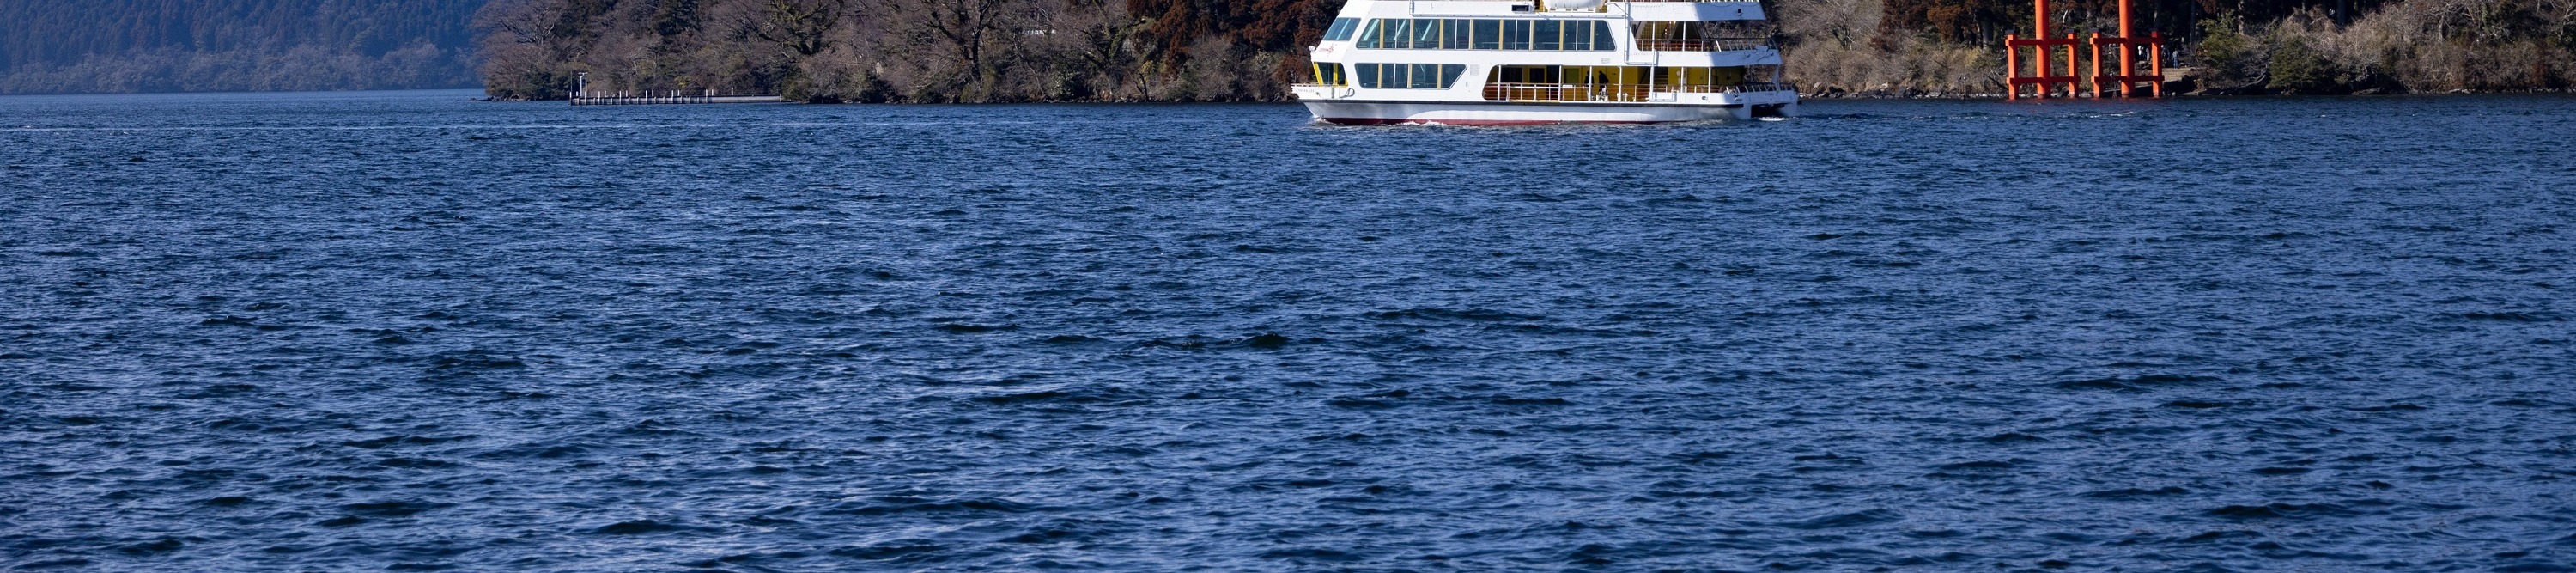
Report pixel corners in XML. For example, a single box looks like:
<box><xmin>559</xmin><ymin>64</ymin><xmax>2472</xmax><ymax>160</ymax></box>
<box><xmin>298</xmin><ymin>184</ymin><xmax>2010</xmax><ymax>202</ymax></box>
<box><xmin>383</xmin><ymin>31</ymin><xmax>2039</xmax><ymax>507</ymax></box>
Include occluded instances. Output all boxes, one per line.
<box><xmin>0</xmin><ymin>93</ymin><xmax>2576</xmax><ymax>570</ymax></box>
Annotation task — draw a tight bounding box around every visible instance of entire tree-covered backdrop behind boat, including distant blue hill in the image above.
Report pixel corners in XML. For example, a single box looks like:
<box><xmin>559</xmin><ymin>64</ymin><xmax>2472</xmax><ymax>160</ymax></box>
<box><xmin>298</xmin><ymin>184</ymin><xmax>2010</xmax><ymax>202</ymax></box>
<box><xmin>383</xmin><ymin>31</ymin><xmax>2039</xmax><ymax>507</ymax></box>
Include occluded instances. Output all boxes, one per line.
<box><xmin>0</xmin><ymin>0</ymin><xmax>2576</xmax><ymax>95</ymax></box>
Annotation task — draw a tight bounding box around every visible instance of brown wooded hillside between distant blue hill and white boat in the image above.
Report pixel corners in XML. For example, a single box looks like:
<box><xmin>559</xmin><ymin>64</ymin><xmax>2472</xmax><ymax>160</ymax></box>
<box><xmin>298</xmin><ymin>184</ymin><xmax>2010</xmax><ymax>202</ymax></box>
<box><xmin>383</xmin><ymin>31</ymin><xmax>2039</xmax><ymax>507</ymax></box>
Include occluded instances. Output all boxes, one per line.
<box><xmin>477</xmin><ymin>0</ymin><xmax>1337</xmax><ymax>101</ymax></box>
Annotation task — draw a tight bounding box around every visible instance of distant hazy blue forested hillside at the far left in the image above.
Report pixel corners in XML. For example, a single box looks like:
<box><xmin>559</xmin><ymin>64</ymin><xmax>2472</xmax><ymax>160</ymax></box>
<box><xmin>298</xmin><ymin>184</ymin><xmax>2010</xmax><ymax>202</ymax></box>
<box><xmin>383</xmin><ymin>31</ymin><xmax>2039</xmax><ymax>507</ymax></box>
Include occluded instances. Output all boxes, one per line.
<box><xmin>0</xmin><ymin>0</ymin><xmax>484</xmax><ymax>93</ymax></box>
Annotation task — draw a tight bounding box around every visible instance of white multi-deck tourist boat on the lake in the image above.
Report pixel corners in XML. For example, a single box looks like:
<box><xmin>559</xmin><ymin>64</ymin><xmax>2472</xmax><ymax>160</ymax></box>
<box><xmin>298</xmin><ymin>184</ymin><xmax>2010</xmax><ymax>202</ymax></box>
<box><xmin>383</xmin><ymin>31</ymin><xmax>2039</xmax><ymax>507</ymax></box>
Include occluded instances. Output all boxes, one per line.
<box><xmin>1296</xmin><ymin>0</ymin><xmax>1798</xmax><ymax>126</ymax></box>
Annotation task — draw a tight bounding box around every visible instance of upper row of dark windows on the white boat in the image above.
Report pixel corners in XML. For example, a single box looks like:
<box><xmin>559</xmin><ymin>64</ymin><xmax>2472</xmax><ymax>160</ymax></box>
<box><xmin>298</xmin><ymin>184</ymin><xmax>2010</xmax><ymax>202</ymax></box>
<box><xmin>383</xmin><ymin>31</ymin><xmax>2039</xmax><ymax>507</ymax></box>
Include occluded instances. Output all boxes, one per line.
<box><xmin>1324</xmin><ymin>18</ymin><xmax>1618</xmax><ymax>52</ymax></box>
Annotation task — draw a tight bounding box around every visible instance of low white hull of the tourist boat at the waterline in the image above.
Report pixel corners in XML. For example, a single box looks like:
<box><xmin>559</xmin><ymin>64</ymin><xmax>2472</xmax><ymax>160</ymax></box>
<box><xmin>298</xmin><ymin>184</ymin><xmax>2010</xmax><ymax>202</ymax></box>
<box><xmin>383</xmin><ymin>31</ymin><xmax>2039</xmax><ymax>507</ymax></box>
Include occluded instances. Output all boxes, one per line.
<box><xmin>1306</xmin><ymin>101</ymin><xmax>1798</xmax><ymax>126</ymax></box>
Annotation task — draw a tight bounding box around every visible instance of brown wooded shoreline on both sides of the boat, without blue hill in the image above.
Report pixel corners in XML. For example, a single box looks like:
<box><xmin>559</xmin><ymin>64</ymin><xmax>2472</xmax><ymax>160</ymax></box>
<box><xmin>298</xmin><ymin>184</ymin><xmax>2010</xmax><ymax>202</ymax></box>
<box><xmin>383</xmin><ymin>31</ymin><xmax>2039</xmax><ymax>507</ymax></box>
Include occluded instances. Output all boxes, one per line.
<box><xmin>477</xmin><ymin>0</ymin><xmax>2576</xmax><ymax>103</ymax></box>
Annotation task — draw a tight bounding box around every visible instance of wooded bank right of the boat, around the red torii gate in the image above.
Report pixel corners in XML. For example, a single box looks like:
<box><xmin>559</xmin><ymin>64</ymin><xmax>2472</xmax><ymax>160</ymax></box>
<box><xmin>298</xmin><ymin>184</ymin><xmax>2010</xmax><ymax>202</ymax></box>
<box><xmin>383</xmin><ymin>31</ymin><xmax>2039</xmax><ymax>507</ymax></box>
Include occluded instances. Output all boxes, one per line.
<box><xmin>1777</xmin><ymin>0</ymin><xmax>2576</xmax><ymax>95</ymax></box>
